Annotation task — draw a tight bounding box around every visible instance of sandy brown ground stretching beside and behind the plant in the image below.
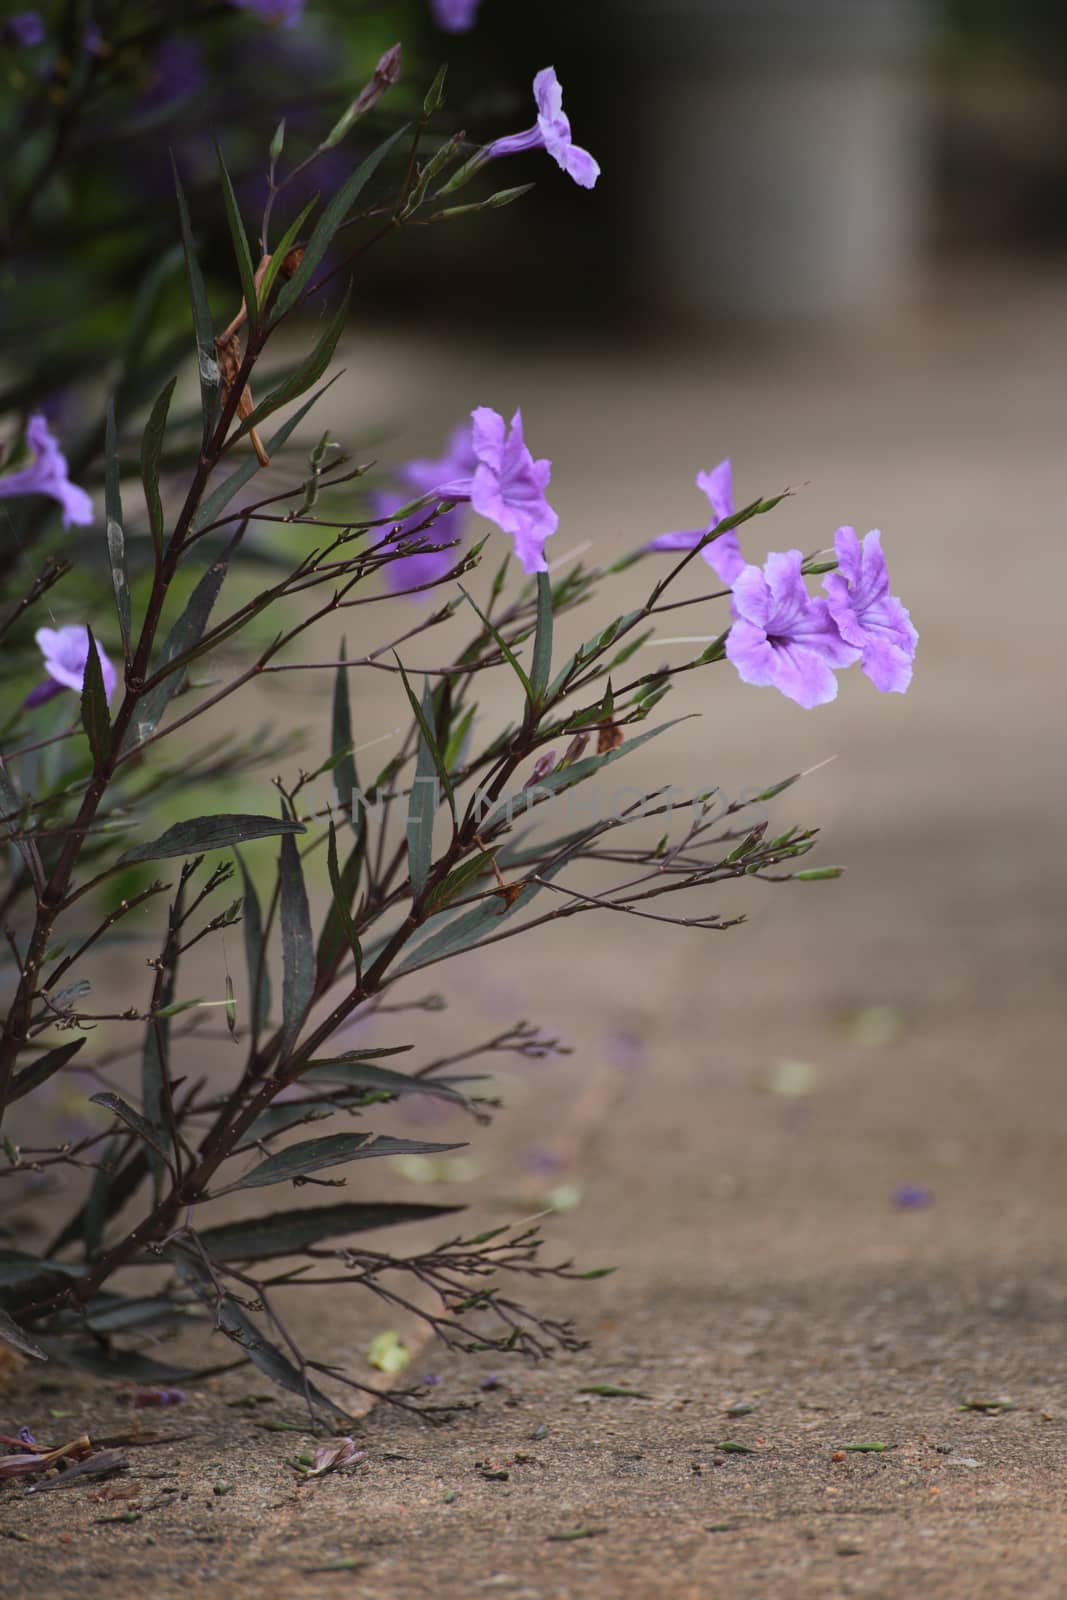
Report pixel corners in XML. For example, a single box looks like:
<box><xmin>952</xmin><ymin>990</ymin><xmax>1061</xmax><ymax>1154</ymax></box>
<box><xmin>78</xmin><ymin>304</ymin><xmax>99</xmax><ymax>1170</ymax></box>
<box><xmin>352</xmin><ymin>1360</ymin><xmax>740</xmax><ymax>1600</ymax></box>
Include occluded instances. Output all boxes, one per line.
<box><xmin>0</xmin><ymin>278</ymin><xmax>1067</xmax><ymax>1600</ymax></box>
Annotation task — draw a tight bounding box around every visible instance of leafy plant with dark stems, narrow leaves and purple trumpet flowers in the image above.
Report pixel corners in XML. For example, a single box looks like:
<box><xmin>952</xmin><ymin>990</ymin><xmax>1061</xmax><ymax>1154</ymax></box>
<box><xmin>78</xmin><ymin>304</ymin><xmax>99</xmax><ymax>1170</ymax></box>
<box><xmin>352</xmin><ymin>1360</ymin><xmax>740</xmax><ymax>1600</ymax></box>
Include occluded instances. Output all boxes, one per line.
<box><xmin>0</xmin><ymin>0</ymin><xmax>915</xmax><ymax>1419</ymax></box>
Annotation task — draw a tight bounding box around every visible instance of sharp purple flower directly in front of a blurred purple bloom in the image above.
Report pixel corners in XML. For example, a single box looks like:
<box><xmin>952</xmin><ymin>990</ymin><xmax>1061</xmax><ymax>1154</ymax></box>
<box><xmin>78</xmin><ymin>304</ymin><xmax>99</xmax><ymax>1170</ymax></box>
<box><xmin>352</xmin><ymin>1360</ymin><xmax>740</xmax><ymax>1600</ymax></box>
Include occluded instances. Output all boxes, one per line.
<box><xmin>434</xmin><ymin>405</ymin><xmax>560</xmax><ymax>573</ymax></box>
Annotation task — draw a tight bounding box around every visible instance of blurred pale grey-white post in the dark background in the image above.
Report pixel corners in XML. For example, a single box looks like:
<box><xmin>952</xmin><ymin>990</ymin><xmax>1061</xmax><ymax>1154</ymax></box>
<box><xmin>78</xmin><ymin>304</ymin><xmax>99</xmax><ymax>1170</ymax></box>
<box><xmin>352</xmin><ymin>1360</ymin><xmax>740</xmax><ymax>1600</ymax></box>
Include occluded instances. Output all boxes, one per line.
<box><xmin>621</xmin><ymin>0</ymin><xmax>928</xmax><ymax>322</ymax></box>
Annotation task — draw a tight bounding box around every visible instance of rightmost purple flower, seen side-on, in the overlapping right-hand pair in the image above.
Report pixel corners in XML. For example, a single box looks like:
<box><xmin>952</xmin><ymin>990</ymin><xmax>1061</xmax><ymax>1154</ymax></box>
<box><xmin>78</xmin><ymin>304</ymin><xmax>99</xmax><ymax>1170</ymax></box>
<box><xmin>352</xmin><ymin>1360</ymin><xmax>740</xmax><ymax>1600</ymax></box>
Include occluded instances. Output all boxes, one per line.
<box><xmin>822</xmin><ymin>528</ymin><xmax>918</xmax><ymax>694</ymax></box>
